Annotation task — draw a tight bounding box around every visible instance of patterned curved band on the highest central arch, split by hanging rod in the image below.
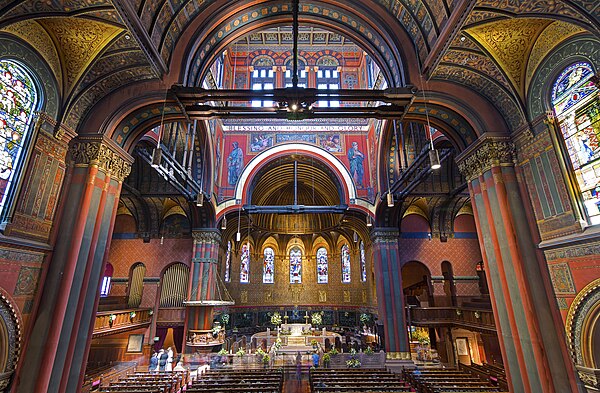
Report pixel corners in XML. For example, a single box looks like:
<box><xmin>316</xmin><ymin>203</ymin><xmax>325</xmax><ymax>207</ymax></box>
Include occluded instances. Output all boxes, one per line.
<box><xmin>186</xmin><ymin>3</ymin><xmax>403</xmax><ymax>85</ymax></box>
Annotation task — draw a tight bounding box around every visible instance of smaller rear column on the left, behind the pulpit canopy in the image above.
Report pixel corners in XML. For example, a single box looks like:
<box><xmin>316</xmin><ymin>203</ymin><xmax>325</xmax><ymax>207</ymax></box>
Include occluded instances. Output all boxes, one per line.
<box><xmin>184</xmin><ymin>229</ymin><xmax>223</xmax><ymax>351</ymax></box>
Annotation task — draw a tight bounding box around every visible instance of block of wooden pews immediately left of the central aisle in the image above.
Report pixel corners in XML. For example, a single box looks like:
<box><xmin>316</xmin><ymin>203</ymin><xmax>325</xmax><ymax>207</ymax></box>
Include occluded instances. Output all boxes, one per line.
<box><xmin>186</xmin><ymin>369</ymin><xmax>283</xmax><ymax>393</ymax></box>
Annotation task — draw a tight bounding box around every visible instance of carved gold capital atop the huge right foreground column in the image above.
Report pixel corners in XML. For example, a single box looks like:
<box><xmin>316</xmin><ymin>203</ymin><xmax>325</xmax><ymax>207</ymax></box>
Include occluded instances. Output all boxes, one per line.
<box><xmin>456</xmin><ymin>133</ymin><xmax>516</xmax><ymax>181</ymax></box>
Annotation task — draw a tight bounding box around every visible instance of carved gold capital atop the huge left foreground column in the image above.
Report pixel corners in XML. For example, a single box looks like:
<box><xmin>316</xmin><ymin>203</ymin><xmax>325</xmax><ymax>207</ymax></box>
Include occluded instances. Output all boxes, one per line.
<box><xmin>69</xmin><ymin>137</ymin><xmax>133</xmax><ymax>182</ymax></box>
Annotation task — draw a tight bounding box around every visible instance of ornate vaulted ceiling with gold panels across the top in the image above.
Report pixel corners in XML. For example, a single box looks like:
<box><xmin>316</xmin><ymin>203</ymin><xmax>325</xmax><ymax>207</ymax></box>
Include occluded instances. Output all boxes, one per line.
<box><xmin>0</xmin><ymin>0</ymin><xmax>600</xmax><ymax>139</ymax></box>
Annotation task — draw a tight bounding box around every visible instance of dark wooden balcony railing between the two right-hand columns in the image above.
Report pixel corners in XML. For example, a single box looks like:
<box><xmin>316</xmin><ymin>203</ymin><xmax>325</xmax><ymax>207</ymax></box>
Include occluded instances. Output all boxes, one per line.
<box><xmin>410</xmin><ymin>307</ymin><xmax>496</xmax><ymax>331</ymax></box>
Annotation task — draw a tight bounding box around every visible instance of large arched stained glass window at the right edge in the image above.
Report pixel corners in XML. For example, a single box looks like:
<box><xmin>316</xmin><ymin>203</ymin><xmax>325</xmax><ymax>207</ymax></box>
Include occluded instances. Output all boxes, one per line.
<box><xmin>552</xmin><ymin>62</ymin><xmax>600</xmax><ymax>224</ymax></box>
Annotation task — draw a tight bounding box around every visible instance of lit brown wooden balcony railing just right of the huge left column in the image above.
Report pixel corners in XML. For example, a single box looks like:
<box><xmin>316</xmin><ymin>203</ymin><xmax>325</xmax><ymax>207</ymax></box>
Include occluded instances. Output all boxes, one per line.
<box><xmin>92</xmin><ymin>308</ymin><xmax>152</xmax><ymax>338</ymax></box>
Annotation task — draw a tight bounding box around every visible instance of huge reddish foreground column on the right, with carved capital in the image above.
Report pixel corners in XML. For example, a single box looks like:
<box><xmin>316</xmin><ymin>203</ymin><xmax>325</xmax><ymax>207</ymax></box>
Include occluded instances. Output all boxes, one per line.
<box><xmin>457</xmin><ymin>135</ymin><xmax>577</xmax><ymax>392</ymax></box>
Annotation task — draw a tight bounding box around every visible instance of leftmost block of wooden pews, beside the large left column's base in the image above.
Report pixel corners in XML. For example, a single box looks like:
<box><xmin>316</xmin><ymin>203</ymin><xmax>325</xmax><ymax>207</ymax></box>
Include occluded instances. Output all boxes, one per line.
<box><xmin>100</xmin><ymin>371</ymin><xmax>190</xmax><ymax>393</ymax></box>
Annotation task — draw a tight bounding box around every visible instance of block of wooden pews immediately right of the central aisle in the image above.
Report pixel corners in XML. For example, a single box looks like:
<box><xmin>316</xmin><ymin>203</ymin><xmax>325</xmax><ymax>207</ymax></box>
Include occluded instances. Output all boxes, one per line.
<box><xmin>309</xmin><ymin>368</ymin><xmax>415</xmax><ymax>393</ymax></box>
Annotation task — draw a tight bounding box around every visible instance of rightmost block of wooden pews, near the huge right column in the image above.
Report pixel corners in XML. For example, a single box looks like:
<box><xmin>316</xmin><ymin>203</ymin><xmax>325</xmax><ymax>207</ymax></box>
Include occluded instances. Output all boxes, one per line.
<box><xmin>402</xmin><ymin>369</ymin><xmax>502</xmax><ymax>393</ymax></box>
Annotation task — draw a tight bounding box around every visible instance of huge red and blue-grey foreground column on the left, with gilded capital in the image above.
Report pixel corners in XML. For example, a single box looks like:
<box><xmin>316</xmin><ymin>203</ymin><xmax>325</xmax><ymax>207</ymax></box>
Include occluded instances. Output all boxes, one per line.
<box><xmin>16</xmin><ymin>136</ymin><xmax>133</xmax><ymax>392</ymax></box>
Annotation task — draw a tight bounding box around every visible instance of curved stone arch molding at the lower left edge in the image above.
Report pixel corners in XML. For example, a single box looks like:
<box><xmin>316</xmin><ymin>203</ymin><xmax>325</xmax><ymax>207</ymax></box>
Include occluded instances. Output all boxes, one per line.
<box><xmin>0</xmin><ymin>288</ymin><xmax>22</xmax><ymax>392</ymax></box>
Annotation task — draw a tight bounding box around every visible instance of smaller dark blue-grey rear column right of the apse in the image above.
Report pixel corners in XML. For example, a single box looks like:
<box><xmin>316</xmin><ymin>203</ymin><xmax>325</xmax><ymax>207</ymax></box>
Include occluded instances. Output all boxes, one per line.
<box><xmin>371</xmin><ymin>228</ymin><xmax>410</xmax><ymax>363</ymax></box>
